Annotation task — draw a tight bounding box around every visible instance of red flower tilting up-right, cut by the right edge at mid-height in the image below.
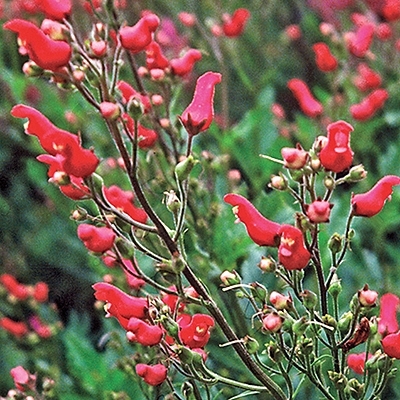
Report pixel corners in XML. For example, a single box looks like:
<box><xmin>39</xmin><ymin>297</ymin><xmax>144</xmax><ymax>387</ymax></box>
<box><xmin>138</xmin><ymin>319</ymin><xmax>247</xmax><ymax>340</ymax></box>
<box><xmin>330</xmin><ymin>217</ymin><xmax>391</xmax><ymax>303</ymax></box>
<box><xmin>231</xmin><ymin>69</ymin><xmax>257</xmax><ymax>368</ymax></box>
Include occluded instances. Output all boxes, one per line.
<box><xmin>351</xmin><ymin>175</ymin><xmax>400</xmax><ymax>217</ymax></box>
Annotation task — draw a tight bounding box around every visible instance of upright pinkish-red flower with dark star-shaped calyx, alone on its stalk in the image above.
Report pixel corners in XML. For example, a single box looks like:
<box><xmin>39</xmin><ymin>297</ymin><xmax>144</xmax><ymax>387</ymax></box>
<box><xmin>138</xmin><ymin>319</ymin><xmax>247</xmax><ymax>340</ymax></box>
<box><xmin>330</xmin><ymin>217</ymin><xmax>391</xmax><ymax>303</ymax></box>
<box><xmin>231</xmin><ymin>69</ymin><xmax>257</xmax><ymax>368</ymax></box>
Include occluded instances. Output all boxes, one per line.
<box><xmin>179</xmin><ymin>72</ymin><xmax>222</xmax><ymax>136</ymax></box>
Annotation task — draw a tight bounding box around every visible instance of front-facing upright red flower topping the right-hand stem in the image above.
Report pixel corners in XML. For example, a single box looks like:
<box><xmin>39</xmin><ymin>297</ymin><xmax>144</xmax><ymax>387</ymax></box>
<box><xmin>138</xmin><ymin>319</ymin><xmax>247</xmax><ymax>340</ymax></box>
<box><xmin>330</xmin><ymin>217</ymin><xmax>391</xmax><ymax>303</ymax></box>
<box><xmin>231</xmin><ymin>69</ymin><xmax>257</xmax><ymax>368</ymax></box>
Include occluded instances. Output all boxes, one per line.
<box><xmin>319</xmin><ymin>121</ymin><xmax>353</xmax><ymax>172</ymax></box>
